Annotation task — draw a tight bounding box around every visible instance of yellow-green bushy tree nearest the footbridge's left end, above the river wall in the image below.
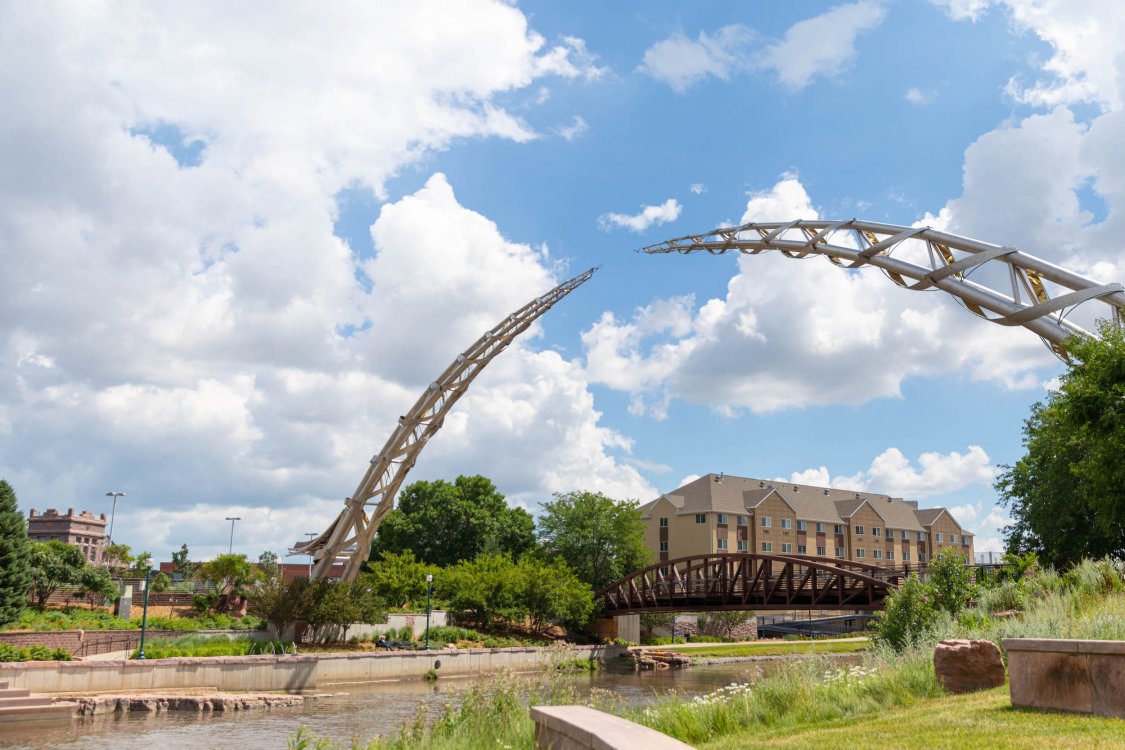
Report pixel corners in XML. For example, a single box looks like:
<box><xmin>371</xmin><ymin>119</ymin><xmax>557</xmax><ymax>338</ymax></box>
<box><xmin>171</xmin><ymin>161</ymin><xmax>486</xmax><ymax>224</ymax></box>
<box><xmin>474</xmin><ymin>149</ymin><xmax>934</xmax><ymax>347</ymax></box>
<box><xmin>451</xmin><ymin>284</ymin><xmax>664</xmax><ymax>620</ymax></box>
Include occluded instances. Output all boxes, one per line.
<box><xmin>518</xmin><ymin>555</ymin><xmax>594</xmax><ymax>633</ymax></box>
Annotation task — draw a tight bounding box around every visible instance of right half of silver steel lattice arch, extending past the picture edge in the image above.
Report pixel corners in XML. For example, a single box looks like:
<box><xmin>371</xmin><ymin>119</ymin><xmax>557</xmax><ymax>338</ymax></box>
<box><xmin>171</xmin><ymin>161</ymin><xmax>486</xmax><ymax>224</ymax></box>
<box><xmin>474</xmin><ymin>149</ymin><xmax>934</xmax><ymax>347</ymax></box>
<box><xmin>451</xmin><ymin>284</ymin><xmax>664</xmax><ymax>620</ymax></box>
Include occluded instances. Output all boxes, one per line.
<box><xmin>638</xmin><ymin>219</ymin><xmax>1125</xmax><ymax>359</ymax></box>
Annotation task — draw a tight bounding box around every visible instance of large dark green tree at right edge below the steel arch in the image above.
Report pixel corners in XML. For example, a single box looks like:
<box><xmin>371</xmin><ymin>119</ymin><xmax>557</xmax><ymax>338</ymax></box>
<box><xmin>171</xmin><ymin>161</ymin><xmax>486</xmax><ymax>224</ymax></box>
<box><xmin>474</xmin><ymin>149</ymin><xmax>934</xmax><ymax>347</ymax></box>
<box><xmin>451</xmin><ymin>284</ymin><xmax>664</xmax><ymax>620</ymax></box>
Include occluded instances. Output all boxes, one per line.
<box><xmin>996</xmin><ymin>324</ymin><xmax>1125</xmax><ymax>568</ymax></box>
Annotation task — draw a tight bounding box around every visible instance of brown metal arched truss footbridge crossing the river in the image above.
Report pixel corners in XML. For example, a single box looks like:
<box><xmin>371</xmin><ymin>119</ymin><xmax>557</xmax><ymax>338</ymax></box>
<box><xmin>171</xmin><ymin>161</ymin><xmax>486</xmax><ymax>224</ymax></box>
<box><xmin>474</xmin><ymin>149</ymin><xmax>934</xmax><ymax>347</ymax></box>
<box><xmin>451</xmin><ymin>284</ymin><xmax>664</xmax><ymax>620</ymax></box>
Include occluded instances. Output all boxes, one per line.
<box><xmin>596</xmin><ymin>552</ymin><xmax>907</xmax><ymax>616</ymax></box>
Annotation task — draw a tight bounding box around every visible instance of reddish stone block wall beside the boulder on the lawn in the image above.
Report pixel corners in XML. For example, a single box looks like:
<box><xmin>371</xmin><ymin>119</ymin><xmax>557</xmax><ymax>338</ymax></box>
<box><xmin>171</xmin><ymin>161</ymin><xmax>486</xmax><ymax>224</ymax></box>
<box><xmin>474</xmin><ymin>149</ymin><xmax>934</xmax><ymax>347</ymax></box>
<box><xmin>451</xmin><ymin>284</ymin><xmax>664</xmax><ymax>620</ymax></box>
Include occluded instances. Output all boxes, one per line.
<box><xmin>1004</xmin><ymin>638</ymin><xmax>1125</xmax><ymax>719</ymax></box>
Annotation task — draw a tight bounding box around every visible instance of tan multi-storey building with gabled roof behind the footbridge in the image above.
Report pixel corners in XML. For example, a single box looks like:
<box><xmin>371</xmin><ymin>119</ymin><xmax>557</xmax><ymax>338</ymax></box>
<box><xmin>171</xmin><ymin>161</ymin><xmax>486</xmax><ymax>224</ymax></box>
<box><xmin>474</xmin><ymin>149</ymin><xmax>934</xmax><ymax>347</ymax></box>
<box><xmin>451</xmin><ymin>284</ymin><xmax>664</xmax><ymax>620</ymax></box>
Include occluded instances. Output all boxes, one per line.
<box><xmin>640</xmin><ymin>475</ymin><xmax>974</xmax><ymax>568</ymax></box>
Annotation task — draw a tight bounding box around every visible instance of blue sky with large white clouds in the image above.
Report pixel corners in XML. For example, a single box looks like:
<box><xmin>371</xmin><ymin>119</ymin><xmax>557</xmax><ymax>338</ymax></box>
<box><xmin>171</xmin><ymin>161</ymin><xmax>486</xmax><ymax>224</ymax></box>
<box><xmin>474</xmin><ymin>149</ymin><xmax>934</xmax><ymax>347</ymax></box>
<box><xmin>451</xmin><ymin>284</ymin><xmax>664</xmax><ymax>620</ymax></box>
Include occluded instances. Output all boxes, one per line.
<box><xmin>0</xmin><ymin>0</ymin><xmax>1125</xmax><ymax>557</ymax></box>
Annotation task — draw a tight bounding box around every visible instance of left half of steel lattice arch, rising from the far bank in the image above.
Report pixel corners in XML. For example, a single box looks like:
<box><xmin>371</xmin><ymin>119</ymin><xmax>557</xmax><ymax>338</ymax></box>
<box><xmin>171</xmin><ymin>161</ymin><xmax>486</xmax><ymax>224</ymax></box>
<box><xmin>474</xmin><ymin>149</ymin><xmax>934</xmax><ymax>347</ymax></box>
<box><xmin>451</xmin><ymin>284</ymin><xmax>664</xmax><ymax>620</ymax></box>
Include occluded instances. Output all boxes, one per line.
<box><xmin>289</xmin><ymin>268</ymin><xmax>597</xmax><ymax>580</ymax></box>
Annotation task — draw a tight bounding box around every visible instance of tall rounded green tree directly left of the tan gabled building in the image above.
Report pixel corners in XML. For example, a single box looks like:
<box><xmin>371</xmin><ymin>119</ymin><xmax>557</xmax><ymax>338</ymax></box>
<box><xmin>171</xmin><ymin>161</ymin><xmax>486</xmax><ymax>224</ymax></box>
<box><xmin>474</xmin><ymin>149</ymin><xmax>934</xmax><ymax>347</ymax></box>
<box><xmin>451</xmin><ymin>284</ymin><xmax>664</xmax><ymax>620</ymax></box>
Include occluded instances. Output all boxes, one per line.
<box><xmin>539</xmin><ymin>491</ymin><xmax>653</xmax><ymax>590</ymax></box>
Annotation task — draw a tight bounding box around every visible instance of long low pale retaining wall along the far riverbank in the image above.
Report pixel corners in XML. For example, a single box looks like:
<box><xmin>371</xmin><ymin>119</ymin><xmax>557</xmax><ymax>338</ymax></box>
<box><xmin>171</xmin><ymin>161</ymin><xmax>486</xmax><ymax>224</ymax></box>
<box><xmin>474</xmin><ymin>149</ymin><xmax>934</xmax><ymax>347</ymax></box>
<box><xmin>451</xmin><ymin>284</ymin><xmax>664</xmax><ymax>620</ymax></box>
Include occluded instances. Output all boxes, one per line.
<box><xmin>0</xmin><ymin>645</ymin><xmax>624</xmax><ymax>695</ymax></box>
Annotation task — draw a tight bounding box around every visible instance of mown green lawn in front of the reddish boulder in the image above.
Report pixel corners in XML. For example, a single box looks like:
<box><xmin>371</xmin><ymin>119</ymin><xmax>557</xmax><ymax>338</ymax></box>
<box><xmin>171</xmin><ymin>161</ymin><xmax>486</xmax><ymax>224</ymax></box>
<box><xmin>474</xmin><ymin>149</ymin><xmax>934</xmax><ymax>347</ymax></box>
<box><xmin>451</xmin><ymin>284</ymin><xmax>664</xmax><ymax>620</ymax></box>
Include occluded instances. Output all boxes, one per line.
<box><xmin>700</xmin><ymin>687</ymin><xmax>1125</xmax><ymax>750</ymax></box>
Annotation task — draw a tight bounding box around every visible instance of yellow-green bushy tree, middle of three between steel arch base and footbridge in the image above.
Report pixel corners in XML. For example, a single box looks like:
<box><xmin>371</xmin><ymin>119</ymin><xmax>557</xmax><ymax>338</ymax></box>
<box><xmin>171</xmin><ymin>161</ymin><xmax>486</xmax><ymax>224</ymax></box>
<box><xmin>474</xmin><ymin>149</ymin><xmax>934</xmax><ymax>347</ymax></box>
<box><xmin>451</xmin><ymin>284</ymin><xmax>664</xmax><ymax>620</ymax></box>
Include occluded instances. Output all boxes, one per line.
<box><xmin>434</xmin><ymin>554</ymin><xmax>528</xmax><ymax>627</ymax></box>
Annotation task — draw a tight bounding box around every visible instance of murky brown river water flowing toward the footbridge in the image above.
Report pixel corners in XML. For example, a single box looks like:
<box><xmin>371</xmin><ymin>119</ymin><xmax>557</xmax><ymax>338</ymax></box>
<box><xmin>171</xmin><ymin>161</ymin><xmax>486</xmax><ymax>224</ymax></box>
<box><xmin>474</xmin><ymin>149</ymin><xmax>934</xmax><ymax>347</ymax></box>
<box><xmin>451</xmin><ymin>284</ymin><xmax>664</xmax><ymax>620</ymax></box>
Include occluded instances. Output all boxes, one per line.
<box><xmin>0</xmin><ymin>661</ymin><xmax>850</xmax><ymax>750</ymax></box>
